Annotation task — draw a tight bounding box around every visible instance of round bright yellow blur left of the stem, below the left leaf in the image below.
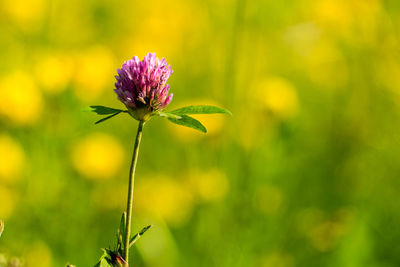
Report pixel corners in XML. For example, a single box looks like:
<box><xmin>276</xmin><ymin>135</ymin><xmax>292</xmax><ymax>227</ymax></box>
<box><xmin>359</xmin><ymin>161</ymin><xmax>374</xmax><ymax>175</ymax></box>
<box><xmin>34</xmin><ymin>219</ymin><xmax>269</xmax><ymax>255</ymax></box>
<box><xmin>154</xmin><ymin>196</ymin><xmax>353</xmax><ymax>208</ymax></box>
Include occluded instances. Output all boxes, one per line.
<box><xmin>71</xmin><ymin>133</ymin><xmax>124</xmax><ymax>179</ymax></box>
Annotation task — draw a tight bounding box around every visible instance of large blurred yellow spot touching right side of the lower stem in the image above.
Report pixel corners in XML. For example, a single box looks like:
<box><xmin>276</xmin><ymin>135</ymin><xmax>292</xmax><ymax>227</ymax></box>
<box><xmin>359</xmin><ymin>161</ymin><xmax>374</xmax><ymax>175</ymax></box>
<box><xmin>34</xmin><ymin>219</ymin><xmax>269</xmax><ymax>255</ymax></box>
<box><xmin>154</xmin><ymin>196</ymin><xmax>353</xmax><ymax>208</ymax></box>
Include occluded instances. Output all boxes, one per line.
<box><xmin>135</xmin><ymin>177</ymin><xmax>193</xmax><ymax>225</ymax></box>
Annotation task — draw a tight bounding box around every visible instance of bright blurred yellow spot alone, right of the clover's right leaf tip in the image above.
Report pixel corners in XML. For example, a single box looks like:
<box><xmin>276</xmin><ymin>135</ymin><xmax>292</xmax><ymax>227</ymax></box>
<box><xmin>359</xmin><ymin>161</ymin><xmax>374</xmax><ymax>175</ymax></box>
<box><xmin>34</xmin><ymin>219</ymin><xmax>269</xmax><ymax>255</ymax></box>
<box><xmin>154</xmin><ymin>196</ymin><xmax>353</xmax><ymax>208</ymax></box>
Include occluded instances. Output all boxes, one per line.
<box><xmin>257</xmin><ymin>77</ymin><xmax>298</xmax><ymax>119</ymax></box>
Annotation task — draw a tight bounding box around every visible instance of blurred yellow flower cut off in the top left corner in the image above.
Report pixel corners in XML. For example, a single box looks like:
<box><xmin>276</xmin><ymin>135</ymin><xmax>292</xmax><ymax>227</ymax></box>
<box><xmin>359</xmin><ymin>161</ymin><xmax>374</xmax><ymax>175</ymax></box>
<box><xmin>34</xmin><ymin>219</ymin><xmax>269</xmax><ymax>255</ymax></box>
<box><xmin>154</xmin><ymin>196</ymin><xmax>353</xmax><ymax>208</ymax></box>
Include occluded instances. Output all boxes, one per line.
<box><xmin>0</xmin><ymin>0</ymin><xmax>47</xmax><ymax>32</ymax></box>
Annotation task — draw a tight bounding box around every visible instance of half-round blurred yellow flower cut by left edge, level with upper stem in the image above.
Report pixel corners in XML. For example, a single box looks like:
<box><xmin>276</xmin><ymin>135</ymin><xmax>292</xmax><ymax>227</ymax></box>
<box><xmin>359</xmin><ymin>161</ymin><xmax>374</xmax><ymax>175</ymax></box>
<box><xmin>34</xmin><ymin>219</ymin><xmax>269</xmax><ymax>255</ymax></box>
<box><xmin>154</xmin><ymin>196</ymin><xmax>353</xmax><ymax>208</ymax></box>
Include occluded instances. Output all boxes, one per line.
<box><xmin>0</xmin><ymin>134</ymin><xmax>25</xmax><ymax>182</ymax></box>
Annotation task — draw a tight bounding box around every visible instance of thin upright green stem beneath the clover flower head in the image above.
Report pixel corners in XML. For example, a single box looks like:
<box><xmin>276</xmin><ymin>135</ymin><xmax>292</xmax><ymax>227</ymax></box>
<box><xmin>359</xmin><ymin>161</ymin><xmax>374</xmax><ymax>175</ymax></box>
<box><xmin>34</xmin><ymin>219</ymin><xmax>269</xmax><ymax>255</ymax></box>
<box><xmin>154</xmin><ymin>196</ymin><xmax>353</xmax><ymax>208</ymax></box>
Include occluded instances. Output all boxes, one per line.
<box><xmin>124</xmin><ymin>121</ymin><xmax>144</xmax><ymax>263</ymax></box>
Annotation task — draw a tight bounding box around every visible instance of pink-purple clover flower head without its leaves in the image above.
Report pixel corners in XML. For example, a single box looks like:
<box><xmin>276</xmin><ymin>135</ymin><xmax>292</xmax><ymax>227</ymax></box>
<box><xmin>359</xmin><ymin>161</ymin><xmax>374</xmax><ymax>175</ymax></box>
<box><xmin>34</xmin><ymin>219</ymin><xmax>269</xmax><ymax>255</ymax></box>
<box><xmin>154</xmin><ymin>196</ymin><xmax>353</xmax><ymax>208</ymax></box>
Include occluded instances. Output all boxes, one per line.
<box><xmin>114</xmin><ymin>53</ymin><xmax>173</xmax><ymax>120</ymax></box>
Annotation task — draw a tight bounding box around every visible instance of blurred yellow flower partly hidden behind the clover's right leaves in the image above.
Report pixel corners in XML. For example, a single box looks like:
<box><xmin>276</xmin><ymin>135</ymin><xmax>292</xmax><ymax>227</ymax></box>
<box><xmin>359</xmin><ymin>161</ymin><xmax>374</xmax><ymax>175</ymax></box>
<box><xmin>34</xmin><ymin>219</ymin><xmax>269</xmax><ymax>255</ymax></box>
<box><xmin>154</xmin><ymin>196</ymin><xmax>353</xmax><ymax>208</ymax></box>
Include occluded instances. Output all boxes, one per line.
<box><xmin>168</xmin><ymin>99</ymin><xmax>226</xmax><ymax>142</ymax></box>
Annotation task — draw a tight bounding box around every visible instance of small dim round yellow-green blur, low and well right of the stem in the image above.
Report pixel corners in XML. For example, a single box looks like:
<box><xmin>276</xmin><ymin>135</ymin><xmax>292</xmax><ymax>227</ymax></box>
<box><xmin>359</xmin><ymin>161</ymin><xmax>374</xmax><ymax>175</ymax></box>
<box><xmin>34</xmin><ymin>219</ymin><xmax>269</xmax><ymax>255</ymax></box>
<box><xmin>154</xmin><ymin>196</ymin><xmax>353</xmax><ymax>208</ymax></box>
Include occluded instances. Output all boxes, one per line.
<box><xmin>254</xmin><ymin>185</ymin><xmax>285</xmax><ymax>215</ymax></box>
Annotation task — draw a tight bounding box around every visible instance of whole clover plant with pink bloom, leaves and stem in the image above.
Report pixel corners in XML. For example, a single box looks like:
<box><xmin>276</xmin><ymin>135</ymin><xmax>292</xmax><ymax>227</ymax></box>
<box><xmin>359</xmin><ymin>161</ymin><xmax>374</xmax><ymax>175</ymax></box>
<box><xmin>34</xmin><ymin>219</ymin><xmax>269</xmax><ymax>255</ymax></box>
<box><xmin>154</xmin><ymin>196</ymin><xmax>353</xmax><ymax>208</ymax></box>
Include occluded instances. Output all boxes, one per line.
<box><xmin>90</xmin><ymin>53</ymin><xmax>230</xmax><ymax>267</ymax></box>
